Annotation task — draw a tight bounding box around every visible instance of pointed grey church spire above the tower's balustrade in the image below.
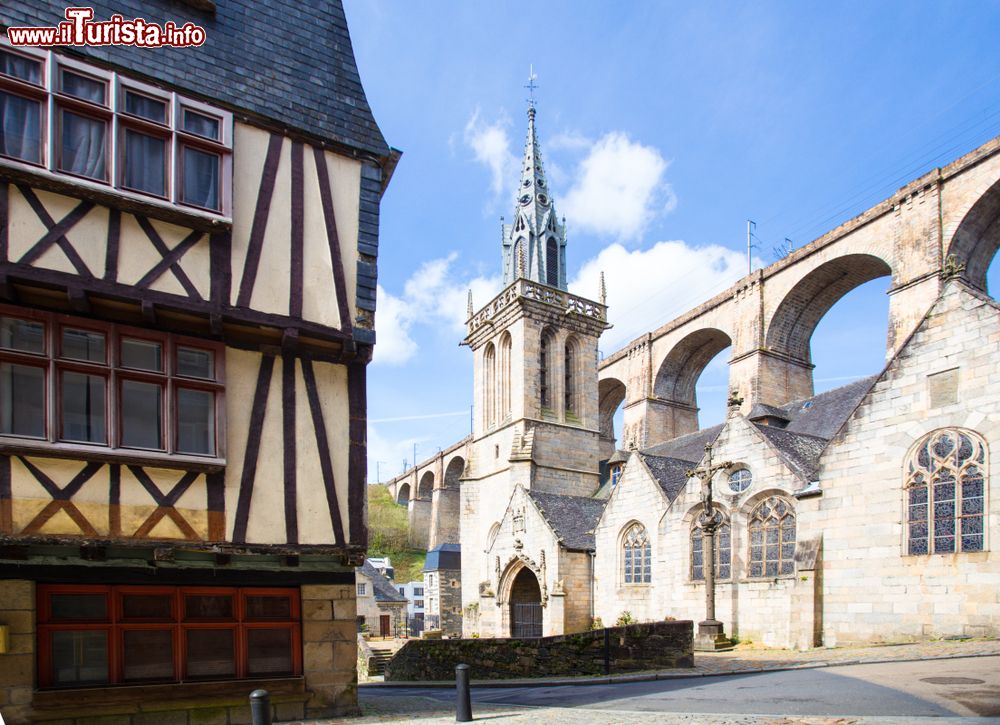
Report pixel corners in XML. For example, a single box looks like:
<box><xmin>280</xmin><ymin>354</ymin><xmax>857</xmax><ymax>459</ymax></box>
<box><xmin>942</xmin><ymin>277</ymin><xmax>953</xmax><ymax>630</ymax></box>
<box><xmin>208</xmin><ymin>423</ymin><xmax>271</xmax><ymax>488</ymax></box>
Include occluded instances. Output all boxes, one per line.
<box><xmin>503</xmin><ymin>72</ymin><xmax>566</xmax><ymax>290</ymax></box>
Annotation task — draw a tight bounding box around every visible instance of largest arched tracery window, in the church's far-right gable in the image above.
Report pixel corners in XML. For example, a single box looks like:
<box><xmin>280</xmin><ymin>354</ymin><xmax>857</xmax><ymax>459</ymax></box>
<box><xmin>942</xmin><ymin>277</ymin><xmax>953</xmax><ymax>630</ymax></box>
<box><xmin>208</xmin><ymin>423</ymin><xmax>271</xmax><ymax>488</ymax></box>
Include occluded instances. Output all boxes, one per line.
<box><xmin>906</xmin><ymin>428</ymin><xmax>987</xmax><ymax>554</ymax></box>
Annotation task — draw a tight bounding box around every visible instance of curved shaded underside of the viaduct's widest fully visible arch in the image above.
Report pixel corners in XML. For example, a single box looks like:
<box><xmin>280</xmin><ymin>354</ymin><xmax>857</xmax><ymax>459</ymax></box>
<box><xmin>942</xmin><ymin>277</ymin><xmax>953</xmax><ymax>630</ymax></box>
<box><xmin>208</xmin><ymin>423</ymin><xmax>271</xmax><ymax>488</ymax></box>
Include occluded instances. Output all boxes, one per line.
<box><xmin>766</xmin><ymin>254</ymin><xmax>892</xmax><ymax>363</ymax></box>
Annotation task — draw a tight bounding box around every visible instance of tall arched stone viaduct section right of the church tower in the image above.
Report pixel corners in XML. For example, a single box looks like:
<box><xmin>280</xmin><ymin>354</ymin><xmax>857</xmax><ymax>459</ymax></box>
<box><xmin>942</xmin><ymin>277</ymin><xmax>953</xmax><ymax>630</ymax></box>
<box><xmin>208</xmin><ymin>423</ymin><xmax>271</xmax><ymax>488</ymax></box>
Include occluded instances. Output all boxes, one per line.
<box><xmin>598</xmin><ymin>137</ymin><xmax>1000</xmax><ymax>455</ymax></box>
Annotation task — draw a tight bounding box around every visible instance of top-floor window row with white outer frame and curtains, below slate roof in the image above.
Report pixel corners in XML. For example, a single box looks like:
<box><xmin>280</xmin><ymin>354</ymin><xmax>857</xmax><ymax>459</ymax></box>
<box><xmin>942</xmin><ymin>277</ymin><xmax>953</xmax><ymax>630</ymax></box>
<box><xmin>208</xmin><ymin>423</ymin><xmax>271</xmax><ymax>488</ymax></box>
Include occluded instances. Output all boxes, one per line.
<box><xmin>0</xmin><ymin>43</ymin><xmax>233</xmax><ymax>215</ymax></box>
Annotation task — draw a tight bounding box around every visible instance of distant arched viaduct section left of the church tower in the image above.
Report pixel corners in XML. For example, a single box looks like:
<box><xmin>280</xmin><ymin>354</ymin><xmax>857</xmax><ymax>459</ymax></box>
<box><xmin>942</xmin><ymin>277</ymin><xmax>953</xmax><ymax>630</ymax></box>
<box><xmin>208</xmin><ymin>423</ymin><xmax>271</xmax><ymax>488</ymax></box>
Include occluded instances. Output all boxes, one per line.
<box><xmin>385</xmin><ymin>436</ymin><xmax>472</xmax><ymax>551</ymax></box>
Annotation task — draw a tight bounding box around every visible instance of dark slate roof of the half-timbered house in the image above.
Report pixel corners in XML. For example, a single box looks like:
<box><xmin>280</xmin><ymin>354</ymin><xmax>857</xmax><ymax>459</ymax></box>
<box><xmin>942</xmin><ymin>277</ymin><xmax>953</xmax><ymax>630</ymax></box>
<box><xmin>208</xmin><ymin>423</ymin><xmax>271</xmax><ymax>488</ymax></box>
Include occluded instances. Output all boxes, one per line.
<box><xmin>7</xmin><ymin>0</ymin><xmax>389</xmax><ymax>156</ymax></box>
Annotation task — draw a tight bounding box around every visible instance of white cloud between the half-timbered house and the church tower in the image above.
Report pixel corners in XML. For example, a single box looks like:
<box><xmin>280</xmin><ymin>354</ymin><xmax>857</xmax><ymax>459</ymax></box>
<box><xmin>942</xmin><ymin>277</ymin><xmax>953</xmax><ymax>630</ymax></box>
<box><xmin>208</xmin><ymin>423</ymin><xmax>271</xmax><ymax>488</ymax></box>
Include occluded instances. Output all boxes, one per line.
<box><xmin>372</xmin><ymin>252</ymin><xmax>500</xmax><ymax>365</ymax></box>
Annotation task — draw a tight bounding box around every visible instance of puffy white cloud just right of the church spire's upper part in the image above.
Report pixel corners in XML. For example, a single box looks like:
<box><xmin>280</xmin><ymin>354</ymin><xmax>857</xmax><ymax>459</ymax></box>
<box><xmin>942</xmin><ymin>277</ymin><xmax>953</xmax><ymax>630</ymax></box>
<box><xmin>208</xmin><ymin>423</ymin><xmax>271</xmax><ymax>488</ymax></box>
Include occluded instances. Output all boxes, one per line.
<box><xmin>561</xmin><ymin>131</ymin><xmax>677</xmax><ymax>240</ymax></box>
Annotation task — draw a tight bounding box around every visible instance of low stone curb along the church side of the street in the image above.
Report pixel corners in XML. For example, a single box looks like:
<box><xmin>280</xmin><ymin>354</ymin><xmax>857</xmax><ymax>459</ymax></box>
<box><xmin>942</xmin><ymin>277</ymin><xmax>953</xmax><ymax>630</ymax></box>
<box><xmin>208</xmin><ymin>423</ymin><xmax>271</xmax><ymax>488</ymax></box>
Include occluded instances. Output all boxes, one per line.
<box><xmin>358</xmin><ymin>652</ymin><xmax>1000</xmax><ymax>690</ymax></box>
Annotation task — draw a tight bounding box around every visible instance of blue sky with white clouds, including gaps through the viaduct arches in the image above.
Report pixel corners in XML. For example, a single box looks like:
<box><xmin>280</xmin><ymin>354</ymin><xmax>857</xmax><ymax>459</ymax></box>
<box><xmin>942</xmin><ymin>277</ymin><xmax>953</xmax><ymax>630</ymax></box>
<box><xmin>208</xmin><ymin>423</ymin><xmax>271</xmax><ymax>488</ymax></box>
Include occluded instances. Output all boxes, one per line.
<box><xmin>345</xmin><ymin>0</ymin><xmax>1000</xmax><ymax>481</ymax></box>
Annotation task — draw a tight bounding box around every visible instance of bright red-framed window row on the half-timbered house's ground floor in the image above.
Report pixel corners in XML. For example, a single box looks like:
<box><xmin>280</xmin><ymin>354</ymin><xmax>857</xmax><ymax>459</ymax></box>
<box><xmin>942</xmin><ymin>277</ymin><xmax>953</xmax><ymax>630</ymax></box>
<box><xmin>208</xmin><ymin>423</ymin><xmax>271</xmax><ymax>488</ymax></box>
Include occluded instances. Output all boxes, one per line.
<box><xmin>38</xmin><ymin>584</ymin><xmax>302</xmax><ymax>688</ymax></box>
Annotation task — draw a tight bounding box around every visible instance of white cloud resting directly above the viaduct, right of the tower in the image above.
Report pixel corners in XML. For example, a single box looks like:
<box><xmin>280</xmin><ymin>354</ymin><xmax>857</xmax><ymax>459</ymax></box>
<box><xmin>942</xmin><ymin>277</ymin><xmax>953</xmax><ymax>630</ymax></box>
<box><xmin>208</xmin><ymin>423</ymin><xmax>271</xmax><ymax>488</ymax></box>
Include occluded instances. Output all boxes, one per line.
<box><xmin>569</xmin><ymin>241</ymin><xmax>762</xmax><ymax>356</ymax></box>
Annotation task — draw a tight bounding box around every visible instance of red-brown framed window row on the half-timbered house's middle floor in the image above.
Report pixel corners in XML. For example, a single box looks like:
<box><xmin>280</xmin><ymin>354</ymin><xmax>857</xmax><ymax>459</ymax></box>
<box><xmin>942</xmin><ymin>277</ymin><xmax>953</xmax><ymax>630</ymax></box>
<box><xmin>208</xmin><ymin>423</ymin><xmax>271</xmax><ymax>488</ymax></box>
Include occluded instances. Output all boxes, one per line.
<box><xmin>0</xmin><ymin>306</ymin><xmax>224</xmax><ymax>458</ymax></box>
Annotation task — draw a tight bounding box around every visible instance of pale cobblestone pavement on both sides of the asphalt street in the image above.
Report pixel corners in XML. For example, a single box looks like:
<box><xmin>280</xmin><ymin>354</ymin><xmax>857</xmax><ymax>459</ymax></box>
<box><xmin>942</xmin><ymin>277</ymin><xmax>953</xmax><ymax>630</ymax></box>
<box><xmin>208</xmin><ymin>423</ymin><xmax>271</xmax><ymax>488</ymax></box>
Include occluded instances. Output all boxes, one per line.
<box><xmin>296</xmin><ymin>640</ymin><xmax>1000</xmax><ymax>725</ymax></box>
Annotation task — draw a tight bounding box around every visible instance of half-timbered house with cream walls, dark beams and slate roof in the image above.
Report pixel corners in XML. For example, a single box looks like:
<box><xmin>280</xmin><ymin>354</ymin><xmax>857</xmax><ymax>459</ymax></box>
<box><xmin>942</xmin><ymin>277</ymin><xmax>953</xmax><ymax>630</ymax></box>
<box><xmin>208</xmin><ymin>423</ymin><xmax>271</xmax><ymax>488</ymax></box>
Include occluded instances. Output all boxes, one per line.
<box><xmin>0</xmin><ymin>0</ymin><xmax>398</xmax><ymax>725</ymax></box>
